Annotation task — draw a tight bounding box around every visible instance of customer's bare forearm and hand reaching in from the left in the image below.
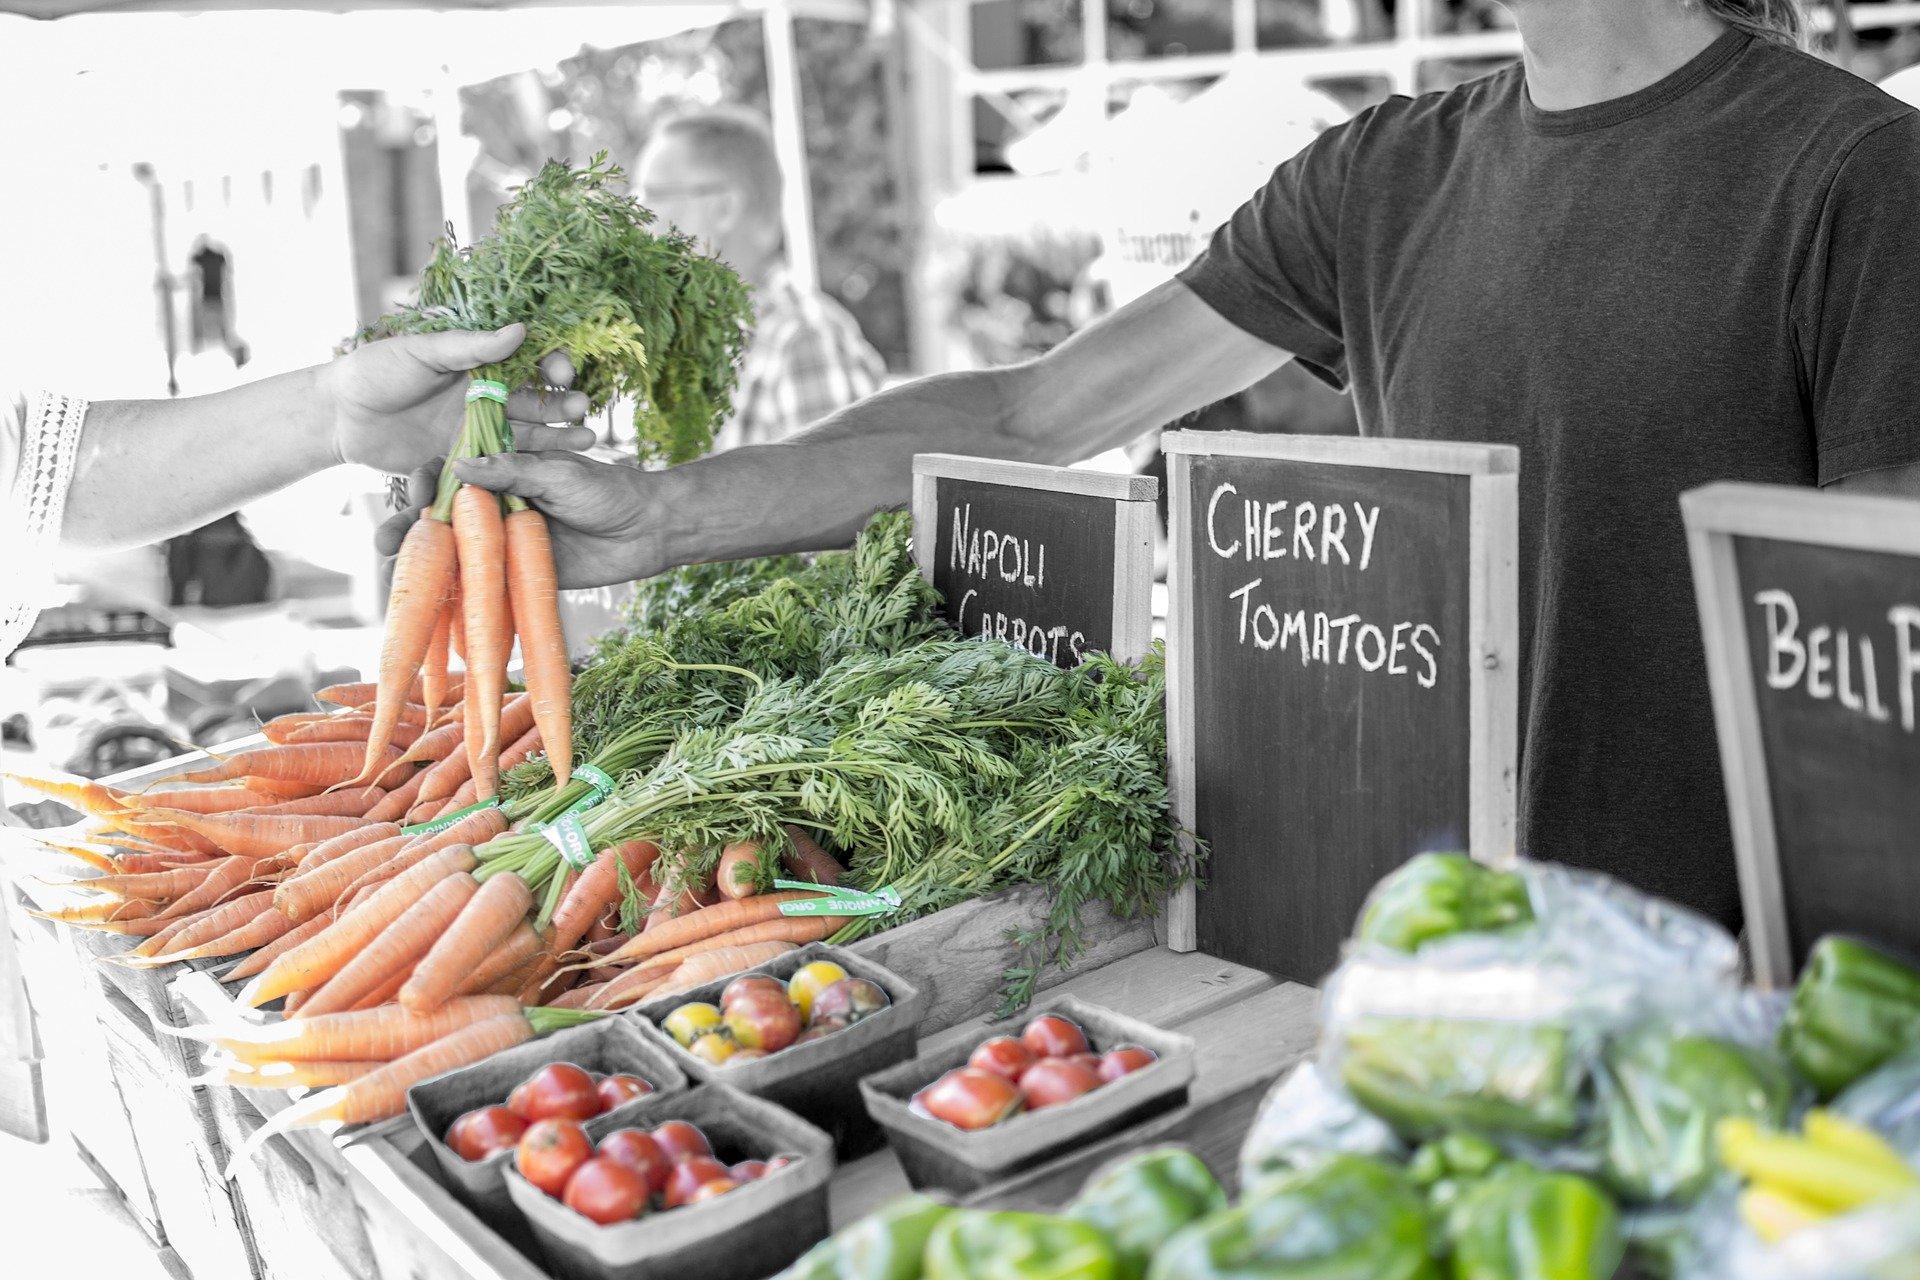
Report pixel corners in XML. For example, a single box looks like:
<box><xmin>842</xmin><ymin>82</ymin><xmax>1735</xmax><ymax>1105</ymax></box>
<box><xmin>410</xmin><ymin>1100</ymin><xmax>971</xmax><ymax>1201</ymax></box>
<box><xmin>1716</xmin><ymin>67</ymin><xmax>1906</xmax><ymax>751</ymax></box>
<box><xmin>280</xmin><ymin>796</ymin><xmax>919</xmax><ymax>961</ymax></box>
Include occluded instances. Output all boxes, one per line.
<box><xmin>61</xmin><ymin>326</ymin><xmax>591</xmax><ymax>551</ymax></box>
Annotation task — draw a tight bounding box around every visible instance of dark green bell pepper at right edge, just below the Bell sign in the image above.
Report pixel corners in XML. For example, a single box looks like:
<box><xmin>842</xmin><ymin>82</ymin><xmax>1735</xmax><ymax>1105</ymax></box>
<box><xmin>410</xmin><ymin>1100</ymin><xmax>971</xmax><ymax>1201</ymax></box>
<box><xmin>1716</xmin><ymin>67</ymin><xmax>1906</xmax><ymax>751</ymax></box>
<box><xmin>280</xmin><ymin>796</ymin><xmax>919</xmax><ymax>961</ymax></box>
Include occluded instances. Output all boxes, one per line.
<box><xmin>1780</xmin><ymin>935</ymin><xmax>1920</xmax><ymax>1100</ymax></box>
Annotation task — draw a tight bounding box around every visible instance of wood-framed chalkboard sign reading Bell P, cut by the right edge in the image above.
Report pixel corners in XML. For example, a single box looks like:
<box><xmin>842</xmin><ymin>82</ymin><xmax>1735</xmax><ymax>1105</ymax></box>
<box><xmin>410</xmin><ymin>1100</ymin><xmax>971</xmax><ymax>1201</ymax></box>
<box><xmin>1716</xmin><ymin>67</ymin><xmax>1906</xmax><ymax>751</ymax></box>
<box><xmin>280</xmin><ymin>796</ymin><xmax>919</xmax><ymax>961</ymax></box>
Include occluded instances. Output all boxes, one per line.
<box><xmin>1680</xmin><ymin>484</ymin><xmax>1920</xmax><ymax>986</ymax></box>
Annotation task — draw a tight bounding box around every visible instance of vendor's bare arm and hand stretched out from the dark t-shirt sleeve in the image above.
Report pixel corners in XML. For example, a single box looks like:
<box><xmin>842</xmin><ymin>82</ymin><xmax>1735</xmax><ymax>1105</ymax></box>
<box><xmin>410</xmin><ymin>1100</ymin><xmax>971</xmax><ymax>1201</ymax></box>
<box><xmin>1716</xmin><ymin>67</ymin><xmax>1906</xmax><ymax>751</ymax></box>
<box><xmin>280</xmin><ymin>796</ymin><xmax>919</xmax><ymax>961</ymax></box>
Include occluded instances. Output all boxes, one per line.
<box><xmin>441</xmin><ymin>282</ymin><xmax>1290</xmax><ymax>587</ymax></box>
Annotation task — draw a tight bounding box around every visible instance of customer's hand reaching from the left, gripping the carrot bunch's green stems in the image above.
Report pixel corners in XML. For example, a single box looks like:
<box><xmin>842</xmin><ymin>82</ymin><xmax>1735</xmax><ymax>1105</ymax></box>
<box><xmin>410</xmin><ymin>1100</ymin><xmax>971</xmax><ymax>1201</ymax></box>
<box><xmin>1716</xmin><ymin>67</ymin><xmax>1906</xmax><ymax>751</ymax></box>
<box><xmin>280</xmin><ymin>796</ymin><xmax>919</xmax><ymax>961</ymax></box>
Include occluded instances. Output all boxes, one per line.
<box><xmin>321</xmin><ymin>324</ymin><xmax>593</xmax><ymax>474</ymax></box>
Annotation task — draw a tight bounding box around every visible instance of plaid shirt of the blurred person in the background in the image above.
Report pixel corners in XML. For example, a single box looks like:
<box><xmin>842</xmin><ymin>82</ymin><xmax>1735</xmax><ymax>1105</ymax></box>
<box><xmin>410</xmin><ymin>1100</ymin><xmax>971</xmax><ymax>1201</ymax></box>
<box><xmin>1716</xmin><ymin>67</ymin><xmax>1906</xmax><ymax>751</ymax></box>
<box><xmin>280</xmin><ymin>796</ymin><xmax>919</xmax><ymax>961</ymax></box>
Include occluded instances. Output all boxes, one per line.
<box><xmin>714</xmin><ymin>267</ymin><xmax>887</xmax><ymax>451</ymax></box>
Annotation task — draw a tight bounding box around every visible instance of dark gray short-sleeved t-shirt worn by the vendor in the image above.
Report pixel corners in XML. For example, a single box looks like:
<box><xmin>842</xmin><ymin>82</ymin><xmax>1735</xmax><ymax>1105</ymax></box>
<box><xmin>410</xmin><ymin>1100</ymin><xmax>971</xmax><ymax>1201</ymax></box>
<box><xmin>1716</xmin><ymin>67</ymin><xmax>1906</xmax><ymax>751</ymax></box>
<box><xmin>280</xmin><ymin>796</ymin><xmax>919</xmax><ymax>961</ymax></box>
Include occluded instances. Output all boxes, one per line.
<box><xmin>1181</xmin><ymin>33</ymin><xmax>1920</xmax><ymax>923</ymax></box>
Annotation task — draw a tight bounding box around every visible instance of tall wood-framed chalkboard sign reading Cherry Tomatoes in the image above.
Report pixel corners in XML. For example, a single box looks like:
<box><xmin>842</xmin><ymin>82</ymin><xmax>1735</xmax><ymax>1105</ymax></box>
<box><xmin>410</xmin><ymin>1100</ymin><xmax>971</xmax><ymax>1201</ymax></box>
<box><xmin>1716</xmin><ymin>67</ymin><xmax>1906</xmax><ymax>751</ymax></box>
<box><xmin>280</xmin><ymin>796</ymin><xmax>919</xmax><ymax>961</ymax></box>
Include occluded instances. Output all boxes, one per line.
<box><xmin>1162</xmin><ymin>432</ymin><xmax>1519</xmax><ymax>983</ymax></box>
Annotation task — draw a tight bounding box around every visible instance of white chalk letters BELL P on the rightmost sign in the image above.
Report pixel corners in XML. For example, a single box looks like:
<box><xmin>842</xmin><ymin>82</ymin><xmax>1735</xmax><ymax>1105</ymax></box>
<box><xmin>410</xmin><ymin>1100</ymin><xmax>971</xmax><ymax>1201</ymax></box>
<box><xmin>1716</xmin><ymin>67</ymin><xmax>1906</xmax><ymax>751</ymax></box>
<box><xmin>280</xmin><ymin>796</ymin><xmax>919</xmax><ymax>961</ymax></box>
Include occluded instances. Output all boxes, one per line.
<box><xmin>1753</xmin><ymin>587</ymin><xmax>1920</xmax><ymax>733</ymax></box>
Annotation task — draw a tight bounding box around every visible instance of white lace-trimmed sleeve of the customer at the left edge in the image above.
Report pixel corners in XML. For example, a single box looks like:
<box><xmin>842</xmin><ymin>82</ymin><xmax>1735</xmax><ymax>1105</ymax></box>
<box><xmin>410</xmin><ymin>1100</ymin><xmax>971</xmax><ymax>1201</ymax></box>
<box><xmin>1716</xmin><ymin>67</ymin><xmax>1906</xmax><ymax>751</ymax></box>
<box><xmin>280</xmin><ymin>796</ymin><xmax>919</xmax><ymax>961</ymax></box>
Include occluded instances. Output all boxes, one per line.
<box><xmin>0</xmin><ymin>391</ymin><xmax>86</xmax><ymax>658</ymax></box>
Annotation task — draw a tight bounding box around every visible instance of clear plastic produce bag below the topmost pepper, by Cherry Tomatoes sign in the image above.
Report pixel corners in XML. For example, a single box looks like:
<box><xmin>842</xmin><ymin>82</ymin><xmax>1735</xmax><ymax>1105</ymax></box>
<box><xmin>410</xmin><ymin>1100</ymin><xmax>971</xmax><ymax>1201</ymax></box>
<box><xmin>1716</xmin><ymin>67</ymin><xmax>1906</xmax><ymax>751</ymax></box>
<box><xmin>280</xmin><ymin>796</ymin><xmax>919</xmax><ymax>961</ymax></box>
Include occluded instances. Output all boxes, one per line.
<box><xmin>1319</xmin><ymin>864</ymin><xmax>1740</xmax><ymax>1161</ymax></box>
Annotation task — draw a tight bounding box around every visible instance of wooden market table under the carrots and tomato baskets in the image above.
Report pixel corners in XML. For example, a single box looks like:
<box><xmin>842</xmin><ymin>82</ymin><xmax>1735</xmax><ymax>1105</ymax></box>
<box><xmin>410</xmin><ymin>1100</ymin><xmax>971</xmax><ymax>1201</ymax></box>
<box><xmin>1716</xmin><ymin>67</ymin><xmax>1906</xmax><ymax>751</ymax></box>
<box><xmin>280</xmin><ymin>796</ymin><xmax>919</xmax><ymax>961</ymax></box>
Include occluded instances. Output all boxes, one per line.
<box><xmin>10</xmin><ymin>740</ymin><xmax>1317</xmax><ymax>1280</ymax></box>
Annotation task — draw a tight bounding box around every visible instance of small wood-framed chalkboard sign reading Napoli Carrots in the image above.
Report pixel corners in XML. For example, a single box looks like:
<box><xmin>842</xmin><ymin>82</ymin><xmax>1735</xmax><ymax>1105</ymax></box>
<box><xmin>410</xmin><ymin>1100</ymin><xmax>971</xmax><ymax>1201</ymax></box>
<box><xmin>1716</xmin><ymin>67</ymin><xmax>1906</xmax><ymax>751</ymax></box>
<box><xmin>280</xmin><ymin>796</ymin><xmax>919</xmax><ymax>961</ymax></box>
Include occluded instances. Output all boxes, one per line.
<box><xmin>914</xmin><ymin>453</ymin><xmax>1160</xmax><ymax>666</ymax></box>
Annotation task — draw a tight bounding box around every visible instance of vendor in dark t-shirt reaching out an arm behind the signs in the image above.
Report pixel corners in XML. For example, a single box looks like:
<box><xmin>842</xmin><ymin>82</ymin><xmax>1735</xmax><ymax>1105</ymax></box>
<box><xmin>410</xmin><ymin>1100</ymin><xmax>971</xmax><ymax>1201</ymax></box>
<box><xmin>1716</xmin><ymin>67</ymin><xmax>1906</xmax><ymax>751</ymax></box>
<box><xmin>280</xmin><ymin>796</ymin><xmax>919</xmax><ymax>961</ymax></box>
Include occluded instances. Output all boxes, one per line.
<box><xmin>389</xmin><ymin>0</ymin><xmax>1920</xmax><ymax>921</ymax></box>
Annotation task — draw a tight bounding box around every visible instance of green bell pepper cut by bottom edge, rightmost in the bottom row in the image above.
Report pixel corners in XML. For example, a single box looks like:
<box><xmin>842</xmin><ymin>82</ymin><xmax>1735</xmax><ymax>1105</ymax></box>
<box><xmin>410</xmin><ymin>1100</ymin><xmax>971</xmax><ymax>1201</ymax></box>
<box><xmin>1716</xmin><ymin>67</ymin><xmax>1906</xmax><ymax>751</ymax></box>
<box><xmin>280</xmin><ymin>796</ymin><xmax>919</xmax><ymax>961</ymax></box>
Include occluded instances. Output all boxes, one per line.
<box><xmin>1448</xmin><ymin>1163</ymin><xmax>1624</xmax><ymax>1280</ymax></box>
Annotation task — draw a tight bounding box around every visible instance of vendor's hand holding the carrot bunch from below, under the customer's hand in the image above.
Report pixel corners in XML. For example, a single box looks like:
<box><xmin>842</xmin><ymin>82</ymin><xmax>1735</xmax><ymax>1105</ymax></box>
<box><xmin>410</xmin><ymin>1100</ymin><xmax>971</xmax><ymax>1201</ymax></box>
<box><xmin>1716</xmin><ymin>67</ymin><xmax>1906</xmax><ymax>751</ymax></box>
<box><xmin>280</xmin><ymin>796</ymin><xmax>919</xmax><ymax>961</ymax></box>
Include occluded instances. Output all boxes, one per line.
<box><xmin>376</xmin><ymin>451</ymin><xmax>664</xmax><ymax>587</ymax></box>
